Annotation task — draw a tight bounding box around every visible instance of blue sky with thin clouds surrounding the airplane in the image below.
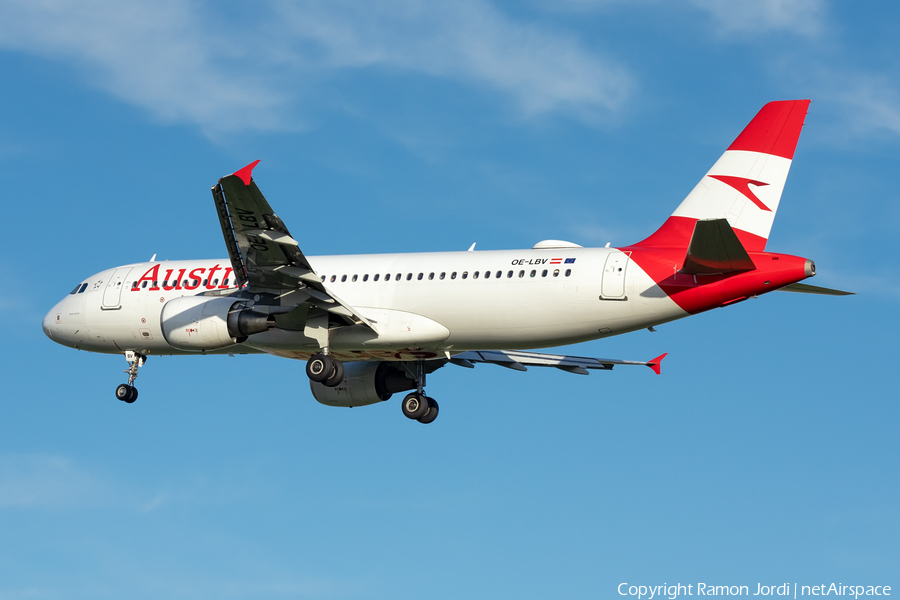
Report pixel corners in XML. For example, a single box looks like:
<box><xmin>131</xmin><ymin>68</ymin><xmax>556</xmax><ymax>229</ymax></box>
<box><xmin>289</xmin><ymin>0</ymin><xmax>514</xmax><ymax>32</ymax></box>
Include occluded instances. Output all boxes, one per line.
<box><xmin>0</xmin><ymin>0</ymin><xmax>900</xmax><ymax>600</ymax></box>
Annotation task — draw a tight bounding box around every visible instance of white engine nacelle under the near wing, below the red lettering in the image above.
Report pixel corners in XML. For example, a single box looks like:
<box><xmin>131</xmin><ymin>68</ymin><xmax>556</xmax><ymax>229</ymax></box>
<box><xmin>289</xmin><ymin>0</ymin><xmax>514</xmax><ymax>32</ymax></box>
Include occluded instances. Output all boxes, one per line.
<box><xmin>160</xmin><ymin>296</ymin><xmax>275</xmax><ymax>351</ymax></box>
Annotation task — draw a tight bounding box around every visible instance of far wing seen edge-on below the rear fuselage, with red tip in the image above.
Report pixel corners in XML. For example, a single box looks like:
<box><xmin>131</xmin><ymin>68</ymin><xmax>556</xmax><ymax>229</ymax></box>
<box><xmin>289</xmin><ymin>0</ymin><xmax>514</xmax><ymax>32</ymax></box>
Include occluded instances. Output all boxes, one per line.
<box><xmin>450</xmin><ymin>350</ymin><xmax>668</xmax><ymax>375</ymax></box>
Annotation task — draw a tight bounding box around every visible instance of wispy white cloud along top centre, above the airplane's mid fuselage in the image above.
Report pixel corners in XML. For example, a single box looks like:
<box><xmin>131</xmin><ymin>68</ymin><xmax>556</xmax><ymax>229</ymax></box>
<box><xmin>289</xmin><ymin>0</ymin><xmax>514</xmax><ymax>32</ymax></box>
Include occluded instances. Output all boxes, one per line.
<box><xmin>278</xmin><ymin>0</ymin><xmax>631</xmax><ymax>116</ymax></box>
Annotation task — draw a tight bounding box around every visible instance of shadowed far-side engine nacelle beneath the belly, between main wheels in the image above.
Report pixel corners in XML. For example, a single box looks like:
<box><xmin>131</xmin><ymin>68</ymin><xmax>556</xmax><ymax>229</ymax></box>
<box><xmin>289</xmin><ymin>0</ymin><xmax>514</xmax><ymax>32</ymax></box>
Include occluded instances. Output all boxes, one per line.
<box><xmin>309</xmin><ymin>361</ymin><xmax>416</xmax><ymax>408</ymax></box>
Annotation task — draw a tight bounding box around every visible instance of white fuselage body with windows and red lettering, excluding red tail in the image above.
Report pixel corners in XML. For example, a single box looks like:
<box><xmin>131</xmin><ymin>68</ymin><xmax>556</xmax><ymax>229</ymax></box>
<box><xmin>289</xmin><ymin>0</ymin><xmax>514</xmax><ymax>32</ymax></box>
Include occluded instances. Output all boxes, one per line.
<box><xmin>43</xmin><ymin>248</ymin><xmax>688</xmax><ymax>360</ymax></box>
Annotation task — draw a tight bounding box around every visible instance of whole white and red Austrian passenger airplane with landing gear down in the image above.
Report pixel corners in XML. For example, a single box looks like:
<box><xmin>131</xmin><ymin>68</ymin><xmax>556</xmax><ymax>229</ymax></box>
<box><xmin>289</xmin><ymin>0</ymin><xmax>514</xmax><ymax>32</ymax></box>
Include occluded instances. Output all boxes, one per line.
<box><xmin>43</xmin><ymin>100</ymin><xmax>850</xmax><ymax>423</ymax></box>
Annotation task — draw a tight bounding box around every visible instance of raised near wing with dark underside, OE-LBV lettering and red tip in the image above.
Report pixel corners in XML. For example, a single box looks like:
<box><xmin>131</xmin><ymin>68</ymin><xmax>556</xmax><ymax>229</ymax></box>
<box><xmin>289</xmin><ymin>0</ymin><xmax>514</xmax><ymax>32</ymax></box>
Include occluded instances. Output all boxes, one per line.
<box><xmin>212</xmin><ymin>161</ymin><xmax>374</xmax><ymax>330</ymax></box>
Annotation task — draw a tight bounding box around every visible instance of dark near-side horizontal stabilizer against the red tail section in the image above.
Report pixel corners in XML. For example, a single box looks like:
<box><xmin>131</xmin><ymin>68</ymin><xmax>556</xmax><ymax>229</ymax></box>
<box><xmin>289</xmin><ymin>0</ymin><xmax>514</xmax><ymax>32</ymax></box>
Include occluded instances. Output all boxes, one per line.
<box><xmin>680</xmin><ymin>219</ymin><xmax>756</xmax><ymax>275</ymax></box>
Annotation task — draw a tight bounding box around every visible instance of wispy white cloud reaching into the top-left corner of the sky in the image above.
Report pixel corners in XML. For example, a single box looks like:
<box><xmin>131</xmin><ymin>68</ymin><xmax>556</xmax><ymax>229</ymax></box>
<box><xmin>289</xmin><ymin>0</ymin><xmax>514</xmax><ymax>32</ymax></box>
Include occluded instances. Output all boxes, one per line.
<box><xmin>0</xmin><ymin>0</ymin><xmax>285</xmax><ymax>135</ymax></box>
